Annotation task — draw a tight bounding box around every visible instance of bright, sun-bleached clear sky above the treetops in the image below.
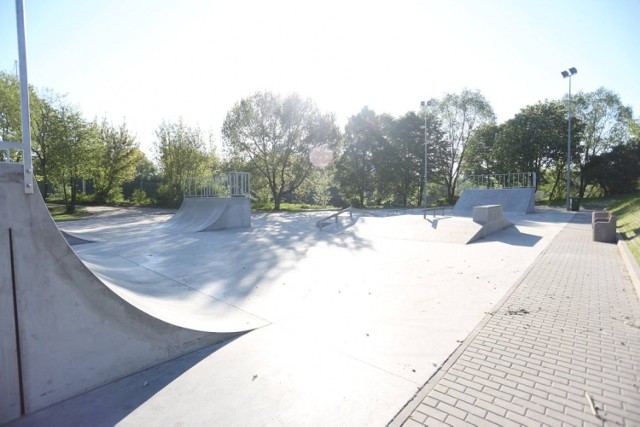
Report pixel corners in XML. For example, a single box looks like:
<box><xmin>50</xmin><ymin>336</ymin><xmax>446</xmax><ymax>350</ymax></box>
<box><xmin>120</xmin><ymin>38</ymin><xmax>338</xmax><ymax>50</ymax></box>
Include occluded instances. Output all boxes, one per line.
<box><xmin>0</xmin><ymin>0</ymin><xmax>640</xmax><ymax>157</ymax></box>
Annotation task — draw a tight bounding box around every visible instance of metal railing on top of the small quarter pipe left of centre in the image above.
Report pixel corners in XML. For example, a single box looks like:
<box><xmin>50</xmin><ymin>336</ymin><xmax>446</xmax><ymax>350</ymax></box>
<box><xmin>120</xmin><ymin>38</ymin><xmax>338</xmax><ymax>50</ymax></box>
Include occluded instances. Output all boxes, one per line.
<box><xmin>184</xmin><ymin>172</ymin><xmax>251</xmax><ymax>197</ymax></box>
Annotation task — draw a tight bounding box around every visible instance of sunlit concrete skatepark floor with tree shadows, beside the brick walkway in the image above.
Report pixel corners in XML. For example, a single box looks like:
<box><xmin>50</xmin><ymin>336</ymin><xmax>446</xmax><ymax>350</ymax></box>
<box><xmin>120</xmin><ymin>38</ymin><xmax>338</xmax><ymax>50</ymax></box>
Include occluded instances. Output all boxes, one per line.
<box><xmin>3</xmin><ymin>188</ymin><xmax>570</xmax><ymax>425</ymax></box>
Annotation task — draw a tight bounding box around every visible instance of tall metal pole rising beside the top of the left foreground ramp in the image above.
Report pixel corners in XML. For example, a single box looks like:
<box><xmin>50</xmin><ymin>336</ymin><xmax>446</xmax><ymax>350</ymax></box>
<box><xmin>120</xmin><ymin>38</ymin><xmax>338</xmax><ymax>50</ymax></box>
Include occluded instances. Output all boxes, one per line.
<box><xmin>16</xmin><ymin>0</ymin><xmax>34</xmax><ymax>194</ymax></box>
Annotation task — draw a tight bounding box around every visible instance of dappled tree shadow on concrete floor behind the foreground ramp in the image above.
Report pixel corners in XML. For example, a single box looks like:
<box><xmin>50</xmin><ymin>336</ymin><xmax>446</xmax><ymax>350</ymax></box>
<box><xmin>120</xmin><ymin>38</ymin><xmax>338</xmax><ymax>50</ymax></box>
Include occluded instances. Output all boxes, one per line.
<box><xmin>67</xmin><ymin>213</ymin><xmax>371</xmax><ymax>303</ymax></box>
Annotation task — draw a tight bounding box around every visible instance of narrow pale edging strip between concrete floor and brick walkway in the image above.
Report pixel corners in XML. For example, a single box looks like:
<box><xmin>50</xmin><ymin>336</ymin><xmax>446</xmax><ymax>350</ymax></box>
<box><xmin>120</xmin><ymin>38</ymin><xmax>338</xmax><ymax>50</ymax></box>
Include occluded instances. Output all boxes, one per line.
<box><xmin>387</xmin><ymin>219</ymin><xmax>573</xmax><ymax>427</ymax></box>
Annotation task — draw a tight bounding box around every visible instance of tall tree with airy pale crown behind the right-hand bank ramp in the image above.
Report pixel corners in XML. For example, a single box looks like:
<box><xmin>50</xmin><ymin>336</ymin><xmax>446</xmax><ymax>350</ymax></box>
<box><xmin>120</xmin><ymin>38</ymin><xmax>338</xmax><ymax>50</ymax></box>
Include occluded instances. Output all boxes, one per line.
<box><xmin>427</xmin><ymin>90</ymin><xmax>495</xmax><ymax>203</ymax></box>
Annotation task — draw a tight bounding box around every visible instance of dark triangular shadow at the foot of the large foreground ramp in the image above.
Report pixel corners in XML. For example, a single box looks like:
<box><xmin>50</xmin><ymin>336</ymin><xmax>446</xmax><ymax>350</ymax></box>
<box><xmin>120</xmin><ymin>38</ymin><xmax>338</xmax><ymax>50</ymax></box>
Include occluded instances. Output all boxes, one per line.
<box><xmin>4</xmin><ymin>335</ymin><xmax>242</xmax><ymax>427</ymax></box>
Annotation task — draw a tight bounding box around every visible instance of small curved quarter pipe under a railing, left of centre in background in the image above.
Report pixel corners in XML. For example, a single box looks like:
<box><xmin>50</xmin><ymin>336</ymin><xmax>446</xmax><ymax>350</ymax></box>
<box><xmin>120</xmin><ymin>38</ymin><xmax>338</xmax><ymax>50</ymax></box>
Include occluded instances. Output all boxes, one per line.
<box><xmin>161</xmin><ymin>197</ymin><xmax>251</xmax><ymax>233</ymax></box>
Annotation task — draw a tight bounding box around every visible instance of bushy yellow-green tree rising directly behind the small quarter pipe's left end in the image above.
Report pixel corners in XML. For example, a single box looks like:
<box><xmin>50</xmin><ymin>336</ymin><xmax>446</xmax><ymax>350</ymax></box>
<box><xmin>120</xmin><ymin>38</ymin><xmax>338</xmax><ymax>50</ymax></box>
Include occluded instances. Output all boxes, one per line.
<box><xmin>154</xmin><ymin>119</ymin><xmax>217</xmax><ymax>206</ymax></box>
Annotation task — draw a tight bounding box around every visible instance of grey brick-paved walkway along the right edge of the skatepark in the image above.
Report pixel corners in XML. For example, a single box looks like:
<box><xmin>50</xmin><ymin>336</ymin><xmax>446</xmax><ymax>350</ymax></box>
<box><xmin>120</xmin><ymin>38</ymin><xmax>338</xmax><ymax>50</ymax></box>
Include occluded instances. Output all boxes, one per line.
<box><xmin>391</xmin><ymin>213</ymin><xmax>640</xmax><ymax>427</ymax></box>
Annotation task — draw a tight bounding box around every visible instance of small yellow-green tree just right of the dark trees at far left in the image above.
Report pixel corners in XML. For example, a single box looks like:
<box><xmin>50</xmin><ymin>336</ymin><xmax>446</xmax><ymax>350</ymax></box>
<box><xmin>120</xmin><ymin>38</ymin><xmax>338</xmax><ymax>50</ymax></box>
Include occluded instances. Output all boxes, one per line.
<box><xmin>92</xmin><ymin>119</ymin><xmax>143</xmax><ymax>203</ymax></box>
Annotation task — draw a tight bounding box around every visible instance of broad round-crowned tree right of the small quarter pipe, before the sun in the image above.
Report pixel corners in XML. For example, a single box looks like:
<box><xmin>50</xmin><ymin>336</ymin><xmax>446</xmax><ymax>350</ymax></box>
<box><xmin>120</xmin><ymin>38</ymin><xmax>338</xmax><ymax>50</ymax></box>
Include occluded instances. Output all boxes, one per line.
<box><xmin>222</xmin><ymin>92</ymin><xmax>340</xmax><ymax>210</ymax></box>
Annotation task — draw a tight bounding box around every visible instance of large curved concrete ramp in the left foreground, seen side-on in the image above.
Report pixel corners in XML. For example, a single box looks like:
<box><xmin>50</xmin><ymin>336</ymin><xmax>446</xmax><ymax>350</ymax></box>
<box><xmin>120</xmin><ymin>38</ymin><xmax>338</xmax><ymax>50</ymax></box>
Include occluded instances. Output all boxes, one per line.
<box><xmin>0</xmin><ymin>164</ymin><xmax>245</xmax><ymax>424</ymax></box>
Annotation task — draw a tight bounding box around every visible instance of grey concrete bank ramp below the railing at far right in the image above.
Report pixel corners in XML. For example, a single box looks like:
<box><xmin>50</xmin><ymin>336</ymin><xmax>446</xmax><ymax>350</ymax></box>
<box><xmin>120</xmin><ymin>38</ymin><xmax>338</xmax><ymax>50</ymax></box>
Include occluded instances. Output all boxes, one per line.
<box><xmin>453</xmin><ymin>188</ymin><xmax>535</xmax><ymax>215</ymax></box>
